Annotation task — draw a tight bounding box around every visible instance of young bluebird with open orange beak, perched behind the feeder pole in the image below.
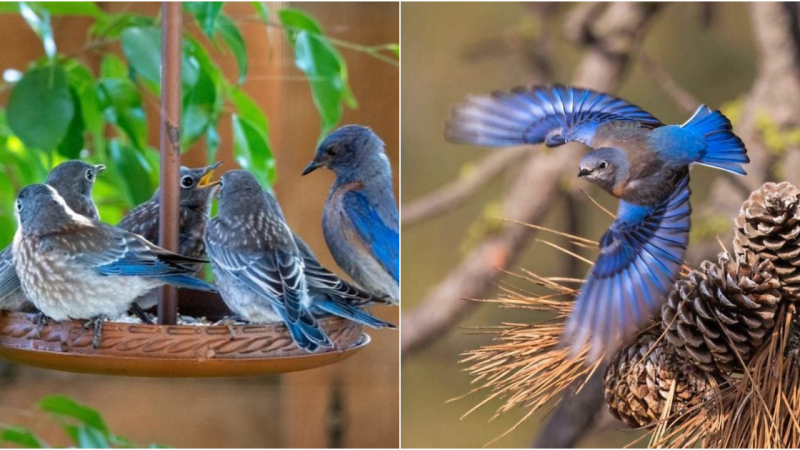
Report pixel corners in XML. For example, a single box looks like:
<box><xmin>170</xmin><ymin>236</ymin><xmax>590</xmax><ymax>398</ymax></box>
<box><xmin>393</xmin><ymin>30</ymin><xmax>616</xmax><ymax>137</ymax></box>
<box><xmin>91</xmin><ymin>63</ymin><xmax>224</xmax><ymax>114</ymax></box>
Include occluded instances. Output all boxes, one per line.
<box><xmin>117</xmin><ymin>162</ymin><xmax>222</xmax><ymax>321</ymax></box>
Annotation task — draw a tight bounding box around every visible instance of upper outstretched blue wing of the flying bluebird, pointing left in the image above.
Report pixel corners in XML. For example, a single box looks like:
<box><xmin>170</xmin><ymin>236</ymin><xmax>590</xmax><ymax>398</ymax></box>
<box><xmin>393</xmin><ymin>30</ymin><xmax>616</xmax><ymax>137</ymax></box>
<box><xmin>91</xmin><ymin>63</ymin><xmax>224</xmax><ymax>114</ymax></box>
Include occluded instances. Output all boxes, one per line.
<box><xmin>445</xmin><ymin>85</ymin><xmax>662</xmax><ymax>147</ymax></box>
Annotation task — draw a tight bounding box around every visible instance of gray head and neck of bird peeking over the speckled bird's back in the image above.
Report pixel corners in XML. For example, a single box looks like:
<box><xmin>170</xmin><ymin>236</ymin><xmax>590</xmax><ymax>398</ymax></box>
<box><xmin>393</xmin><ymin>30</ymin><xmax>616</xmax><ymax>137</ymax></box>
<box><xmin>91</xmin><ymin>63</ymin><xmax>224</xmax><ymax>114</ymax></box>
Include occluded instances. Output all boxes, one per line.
<box><xmin>45</xmin><ymin>161</ymin><xmax>106</xmax><ymax>219</ymax></box>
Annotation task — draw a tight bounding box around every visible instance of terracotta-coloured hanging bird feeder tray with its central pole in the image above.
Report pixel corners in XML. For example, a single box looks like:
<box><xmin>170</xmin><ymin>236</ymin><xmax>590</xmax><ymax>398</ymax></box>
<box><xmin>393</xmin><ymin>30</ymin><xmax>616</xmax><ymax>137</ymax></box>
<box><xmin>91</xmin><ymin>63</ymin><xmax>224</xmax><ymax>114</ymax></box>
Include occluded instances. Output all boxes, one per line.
<box><xmin>0</xmin><ymin>2</ymin><xmax>370</xmax><ymax>377</ymax></box>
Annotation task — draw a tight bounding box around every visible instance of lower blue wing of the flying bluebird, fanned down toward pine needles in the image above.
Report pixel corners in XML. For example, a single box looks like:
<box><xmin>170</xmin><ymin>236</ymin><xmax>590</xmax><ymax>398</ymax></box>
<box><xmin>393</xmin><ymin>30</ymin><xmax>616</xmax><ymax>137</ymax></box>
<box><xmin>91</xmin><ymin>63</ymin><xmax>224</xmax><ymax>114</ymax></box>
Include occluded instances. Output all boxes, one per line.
<box><xmin>562</xmin><ymin>175</ymin><xmax>691</xmax><ymax>362</ymax></box>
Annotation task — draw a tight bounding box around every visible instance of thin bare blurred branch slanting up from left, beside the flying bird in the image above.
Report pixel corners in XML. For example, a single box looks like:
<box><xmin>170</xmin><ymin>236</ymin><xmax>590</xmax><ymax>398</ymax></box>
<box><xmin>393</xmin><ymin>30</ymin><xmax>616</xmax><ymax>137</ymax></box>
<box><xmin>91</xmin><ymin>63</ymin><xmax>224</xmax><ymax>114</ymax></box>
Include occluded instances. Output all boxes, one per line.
<box><xmin>400</xmin><ymin>147</ymin><xmax>529</xmax><ymax>228</ymax></box>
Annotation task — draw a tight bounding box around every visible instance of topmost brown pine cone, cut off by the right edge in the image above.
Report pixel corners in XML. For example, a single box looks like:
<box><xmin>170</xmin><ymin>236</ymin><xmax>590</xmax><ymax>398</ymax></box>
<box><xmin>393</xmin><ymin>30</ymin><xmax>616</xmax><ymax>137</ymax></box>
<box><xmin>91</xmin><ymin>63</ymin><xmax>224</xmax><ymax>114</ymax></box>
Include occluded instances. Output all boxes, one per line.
<box><xmin>733</xmin><ymin>182</ymin><xmax>800</xmax><ymax>301</ymax></box>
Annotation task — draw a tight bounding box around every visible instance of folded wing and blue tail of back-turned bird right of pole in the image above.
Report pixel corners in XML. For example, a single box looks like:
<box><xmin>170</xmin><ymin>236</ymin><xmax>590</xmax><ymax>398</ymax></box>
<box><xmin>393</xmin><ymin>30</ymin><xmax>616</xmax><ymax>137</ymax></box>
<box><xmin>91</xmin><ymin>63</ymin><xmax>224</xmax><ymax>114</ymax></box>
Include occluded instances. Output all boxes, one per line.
<box><xmin>206</xmin><ymin>239</ymin><xmax>333</xmax><ymax>351</ymax></box>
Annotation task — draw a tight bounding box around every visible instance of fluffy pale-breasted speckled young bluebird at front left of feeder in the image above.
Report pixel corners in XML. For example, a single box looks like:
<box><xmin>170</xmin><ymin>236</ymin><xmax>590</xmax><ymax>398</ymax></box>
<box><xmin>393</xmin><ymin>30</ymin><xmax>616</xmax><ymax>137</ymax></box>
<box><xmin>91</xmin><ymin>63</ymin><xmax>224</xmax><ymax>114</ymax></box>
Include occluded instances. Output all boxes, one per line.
<box><xmin>12</xmin><ymin>184</ymin><xmax>216</xmax><ymax>323</ymax></box>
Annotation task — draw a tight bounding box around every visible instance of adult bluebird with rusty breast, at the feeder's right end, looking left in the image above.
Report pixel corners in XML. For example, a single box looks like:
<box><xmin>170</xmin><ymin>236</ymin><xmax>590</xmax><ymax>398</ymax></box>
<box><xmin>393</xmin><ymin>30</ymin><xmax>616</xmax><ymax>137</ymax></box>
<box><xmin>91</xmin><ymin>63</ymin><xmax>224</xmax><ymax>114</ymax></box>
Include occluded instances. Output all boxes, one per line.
<box><xmin>303</xmin><ymin>125</ymin><xmax>400</xmax><ymax>304</ymax></box>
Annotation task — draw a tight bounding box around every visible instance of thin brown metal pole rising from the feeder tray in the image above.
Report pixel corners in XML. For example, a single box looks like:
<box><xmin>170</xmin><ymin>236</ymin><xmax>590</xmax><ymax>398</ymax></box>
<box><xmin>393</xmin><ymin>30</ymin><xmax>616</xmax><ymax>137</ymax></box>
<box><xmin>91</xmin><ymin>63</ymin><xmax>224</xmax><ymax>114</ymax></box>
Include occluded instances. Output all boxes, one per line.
<box><xmin>158</xmin><ymin>2</ymin><xmax>183</xmax><ymax>325</ymax></box>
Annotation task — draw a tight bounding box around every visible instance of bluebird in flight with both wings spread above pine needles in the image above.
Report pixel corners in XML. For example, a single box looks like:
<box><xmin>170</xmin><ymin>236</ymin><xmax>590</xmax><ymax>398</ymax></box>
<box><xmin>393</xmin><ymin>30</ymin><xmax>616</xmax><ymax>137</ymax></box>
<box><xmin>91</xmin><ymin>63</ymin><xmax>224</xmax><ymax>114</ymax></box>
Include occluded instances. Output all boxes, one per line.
<box><xmin>445</xmin><ymin>85</ymin><xmax>749</xmax><ymax>362</ymax></box>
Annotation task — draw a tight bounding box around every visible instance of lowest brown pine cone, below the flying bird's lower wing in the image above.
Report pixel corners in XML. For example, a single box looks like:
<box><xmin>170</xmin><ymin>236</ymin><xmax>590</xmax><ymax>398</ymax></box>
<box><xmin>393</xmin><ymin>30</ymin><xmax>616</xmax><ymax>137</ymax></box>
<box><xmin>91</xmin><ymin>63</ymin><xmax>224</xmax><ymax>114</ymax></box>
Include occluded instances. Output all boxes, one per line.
<box><xmin>603</xmin><ymin>332</ymin><xmax>713</xmax><ymax>428</ymax></box>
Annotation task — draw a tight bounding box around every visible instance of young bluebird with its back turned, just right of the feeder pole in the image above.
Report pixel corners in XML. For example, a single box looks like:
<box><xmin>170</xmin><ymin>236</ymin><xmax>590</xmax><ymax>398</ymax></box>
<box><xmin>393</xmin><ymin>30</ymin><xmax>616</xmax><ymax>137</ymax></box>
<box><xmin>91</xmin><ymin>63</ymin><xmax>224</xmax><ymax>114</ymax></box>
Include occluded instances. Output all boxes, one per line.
<box><xmin>206</xmin><ymin>170</ymin><xmax>333</xmax><ymax>352</ymax></box>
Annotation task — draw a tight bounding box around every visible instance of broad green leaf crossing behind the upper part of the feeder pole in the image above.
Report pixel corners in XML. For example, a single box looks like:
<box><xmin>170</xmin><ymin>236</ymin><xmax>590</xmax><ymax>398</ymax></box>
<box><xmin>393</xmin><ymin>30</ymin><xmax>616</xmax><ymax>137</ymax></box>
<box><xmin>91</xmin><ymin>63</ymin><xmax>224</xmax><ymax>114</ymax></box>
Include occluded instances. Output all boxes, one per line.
<box><xmin>122</xmin><ymin>27</ymin><xmax>199</xmax><ymax>94</ymax></box>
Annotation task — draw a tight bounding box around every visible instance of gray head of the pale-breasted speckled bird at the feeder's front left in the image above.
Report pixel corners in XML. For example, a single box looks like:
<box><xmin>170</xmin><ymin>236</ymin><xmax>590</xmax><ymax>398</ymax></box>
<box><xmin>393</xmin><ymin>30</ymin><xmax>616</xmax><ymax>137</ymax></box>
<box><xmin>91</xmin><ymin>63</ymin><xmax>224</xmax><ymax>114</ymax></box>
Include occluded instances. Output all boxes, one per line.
<box><xmin>16</xmin><ymin>184</ymin><xmax>88</xmax><ymax>234</ymax></box>
